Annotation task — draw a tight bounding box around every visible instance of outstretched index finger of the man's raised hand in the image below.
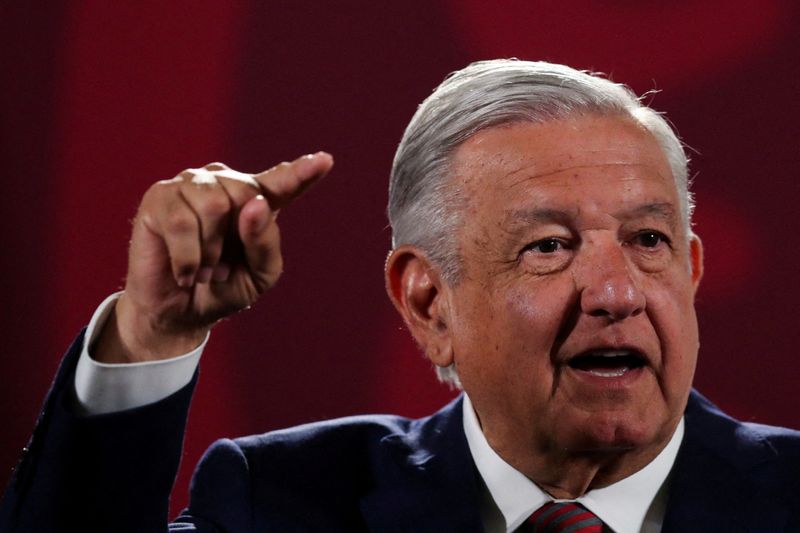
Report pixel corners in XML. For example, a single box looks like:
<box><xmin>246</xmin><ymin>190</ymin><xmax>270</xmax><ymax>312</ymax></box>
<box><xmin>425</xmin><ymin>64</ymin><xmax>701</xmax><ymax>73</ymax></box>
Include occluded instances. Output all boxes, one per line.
<box><xmin>253</xmin><ymin>152</ymin><xmax>333</xmax><ymax>211</ymax></box>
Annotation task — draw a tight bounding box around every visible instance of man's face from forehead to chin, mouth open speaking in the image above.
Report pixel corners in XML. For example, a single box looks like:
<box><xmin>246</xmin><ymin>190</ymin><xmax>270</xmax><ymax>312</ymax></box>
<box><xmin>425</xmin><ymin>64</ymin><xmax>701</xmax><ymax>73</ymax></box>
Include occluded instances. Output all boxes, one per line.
<box><xmin>442</xmin><ymin>116</ymin><xmax>702</xmax><ymax>471</ymax></box>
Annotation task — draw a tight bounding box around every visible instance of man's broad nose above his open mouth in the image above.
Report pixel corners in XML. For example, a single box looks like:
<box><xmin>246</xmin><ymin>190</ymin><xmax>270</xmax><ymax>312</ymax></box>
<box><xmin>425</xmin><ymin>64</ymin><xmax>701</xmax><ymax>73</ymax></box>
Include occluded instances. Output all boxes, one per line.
<box><xmin>575</xmin><ymin>243</ymin><xmax>646</xmax><ymax>321</ymax></box>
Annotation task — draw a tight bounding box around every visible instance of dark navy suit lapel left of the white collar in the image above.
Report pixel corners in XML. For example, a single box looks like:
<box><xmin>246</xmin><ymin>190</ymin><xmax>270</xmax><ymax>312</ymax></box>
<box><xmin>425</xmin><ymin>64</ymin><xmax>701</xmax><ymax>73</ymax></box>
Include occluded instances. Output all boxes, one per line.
<box><xmin>361</xmin><ymin>398</ymin><xmax>483</xmax><ymax>533</ymax></box>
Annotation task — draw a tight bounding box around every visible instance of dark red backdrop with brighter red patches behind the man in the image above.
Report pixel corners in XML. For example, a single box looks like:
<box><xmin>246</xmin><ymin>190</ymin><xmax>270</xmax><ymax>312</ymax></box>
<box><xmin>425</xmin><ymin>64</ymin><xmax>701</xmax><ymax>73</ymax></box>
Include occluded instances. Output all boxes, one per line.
<box><xmin>0</xmin><ymin>0</ymin><xmax>800</xmax><ymax>509</ymax></box>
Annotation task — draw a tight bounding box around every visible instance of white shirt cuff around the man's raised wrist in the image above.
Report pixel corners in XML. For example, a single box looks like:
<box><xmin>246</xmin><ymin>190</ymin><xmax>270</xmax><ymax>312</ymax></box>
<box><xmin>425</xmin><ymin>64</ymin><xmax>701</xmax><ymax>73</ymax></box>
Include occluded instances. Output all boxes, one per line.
<box><xmin>75</xmin><ymin>292</ymin><xmax>209</xmax><ymax>415</ymax></box>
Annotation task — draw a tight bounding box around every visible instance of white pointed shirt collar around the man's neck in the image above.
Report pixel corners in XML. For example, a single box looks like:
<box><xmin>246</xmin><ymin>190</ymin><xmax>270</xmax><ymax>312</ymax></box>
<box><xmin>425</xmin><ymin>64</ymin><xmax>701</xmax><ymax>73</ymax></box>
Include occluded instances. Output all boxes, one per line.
<box><xmin>463</xmin><ymin>394</ymin><xmax>684</xmax><ymax>533</ymax></box>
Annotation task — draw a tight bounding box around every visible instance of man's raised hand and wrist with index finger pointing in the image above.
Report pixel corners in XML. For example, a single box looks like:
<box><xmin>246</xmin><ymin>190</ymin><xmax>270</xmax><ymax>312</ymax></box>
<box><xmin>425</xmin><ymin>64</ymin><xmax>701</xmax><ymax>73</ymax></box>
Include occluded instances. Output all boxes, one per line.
<box><xmin>93</xmin><ymin>152</ymin><xmax>333</xmax><ymax>363</ymax></box>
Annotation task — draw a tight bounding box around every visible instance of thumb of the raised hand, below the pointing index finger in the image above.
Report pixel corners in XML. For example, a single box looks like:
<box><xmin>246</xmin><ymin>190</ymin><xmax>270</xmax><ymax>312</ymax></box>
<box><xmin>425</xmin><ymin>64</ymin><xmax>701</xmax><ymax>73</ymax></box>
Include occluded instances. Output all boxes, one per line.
<box><xmin>238</xmin><ymin>194</ymin><xmax>283</xmax><ymax>292</ymax></box>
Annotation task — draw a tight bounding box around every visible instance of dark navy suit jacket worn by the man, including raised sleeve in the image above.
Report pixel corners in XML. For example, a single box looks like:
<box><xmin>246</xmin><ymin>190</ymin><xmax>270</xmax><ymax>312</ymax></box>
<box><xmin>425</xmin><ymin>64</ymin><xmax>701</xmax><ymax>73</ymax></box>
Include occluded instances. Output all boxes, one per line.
<box><xmin>0</xmin><ymin>330</ymin><xmax>800</xmax><ymax>533</ymax></box>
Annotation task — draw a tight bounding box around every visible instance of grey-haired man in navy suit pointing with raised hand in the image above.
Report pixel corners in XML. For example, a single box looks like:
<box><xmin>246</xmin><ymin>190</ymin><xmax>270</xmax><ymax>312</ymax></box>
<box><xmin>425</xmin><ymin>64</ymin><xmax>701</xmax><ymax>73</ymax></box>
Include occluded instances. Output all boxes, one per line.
<box><xmin>0</xmin><ymin>61</ymin><xmax>800</xmax><ymax>532</ymax></box>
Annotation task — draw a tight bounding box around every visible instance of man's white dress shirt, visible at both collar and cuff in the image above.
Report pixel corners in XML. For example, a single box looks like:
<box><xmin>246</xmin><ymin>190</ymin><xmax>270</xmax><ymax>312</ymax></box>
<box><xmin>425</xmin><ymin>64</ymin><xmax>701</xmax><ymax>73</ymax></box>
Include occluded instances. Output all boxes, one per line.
<box><xmin>75</xmin><ymin>293</ymin><xmax>684</xmax><ymax>533</ymax></box>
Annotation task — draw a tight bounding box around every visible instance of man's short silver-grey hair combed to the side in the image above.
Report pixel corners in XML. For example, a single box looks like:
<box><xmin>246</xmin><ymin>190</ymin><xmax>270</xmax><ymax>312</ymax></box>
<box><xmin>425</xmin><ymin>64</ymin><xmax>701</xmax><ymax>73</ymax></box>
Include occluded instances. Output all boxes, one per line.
<box><xmin>388</xmin><ymin>59</ymin><xmax>694</xmax><ymax>386</ymax></box>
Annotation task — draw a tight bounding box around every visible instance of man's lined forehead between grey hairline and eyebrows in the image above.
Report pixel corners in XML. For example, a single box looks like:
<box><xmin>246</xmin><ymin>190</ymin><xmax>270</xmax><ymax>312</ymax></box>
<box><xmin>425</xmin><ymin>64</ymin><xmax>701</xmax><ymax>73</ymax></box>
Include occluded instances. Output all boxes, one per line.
<box><xmin>451</xmin><ymin>116</ymin><xmax>678</xmax><ymax>217</ymax></box>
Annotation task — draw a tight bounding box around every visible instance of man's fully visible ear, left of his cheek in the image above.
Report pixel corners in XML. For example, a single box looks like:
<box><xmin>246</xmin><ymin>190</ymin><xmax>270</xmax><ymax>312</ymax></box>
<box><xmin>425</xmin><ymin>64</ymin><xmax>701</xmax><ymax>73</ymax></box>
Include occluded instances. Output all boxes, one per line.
<box><xmin>384</xmin><ymin>246</ymin><xmax>453</xmax><ymax>367</ymax></box>
